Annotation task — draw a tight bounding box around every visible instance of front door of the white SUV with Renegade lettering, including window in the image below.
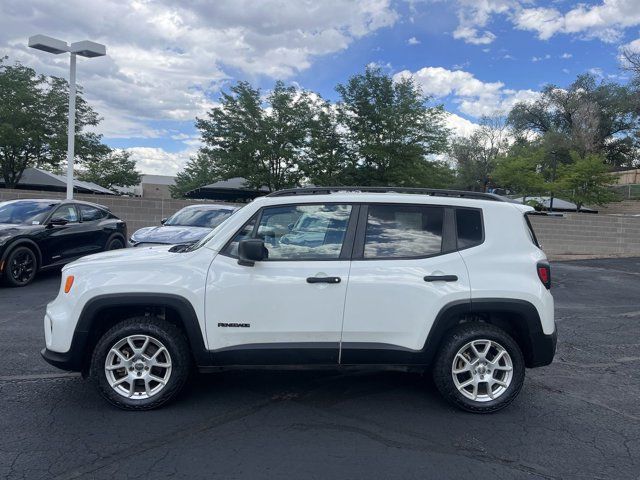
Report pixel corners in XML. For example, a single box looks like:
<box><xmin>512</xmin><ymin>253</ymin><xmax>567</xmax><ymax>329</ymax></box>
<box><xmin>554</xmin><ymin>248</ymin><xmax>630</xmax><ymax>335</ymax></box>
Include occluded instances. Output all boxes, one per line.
<box><xmin>206</xmin><ymin>204</ymin><xmax>357</xmax><ymax>365</ymax></box>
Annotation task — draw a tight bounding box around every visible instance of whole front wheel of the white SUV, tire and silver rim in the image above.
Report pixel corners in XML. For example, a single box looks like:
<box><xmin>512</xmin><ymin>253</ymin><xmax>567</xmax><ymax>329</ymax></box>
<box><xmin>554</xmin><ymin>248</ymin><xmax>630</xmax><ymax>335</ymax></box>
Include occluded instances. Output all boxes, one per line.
<box><xmin>90</xmin><ymin>317</ymin><xmax>191</xmax><ymax>410</ymax></box>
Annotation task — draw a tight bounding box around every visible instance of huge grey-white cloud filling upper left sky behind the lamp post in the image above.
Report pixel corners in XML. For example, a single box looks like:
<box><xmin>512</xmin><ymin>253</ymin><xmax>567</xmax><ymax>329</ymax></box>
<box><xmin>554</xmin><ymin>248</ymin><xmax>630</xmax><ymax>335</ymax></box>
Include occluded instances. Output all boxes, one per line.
<box><xmin>0</xmin><ymin>0</ymin><xmax>398</xmax><ymax>137</ymax></box>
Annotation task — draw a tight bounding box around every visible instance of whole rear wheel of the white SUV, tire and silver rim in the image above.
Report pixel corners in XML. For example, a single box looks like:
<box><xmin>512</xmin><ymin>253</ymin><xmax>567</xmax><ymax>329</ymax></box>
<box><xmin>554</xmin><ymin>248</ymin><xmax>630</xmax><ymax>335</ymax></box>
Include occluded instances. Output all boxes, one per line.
<box><xmin>433</xmin><ymin>323</ymin><xmax>525</xmax><ymax>413</ymax></box>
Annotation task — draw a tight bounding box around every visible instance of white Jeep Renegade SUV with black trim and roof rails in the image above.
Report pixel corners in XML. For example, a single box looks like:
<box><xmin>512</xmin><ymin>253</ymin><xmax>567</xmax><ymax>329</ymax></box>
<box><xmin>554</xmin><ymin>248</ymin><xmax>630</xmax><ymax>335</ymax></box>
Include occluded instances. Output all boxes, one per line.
<box><xmin>42</xmin><ymin>188</ymin><xmax>556</xmax><ymax>412</ymax></box>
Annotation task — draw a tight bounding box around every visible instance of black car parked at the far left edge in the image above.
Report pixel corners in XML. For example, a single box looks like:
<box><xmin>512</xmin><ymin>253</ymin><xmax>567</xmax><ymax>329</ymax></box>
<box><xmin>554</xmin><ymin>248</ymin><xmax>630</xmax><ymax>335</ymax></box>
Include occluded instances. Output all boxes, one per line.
<box><xmin>0</xmin><ymin>199</ymin><xmax>127</xmax><ymax>287</ymax></box>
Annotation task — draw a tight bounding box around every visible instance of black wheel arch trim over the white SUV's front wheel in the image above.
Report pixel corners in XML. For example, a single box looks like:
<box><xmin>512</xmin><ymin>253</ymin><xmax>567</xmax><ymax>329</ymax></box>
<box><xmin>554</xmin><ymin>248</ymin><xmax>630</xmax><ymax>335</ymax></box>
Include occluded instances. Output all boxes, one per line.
<box><xmin>70</xmin><ymin>293</ymin><xmax>209</xmax><ymax>373</ymax></box>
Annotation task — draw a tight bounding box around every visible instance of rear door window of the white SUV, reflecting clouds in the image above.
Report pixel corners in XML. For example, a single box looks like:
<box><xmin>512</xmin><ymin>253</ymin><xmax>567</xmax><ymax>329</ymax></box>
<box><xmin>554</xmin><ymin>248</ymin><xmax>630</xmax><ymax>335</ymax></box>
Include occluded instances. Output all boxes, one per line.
<box><xmin>364</xmin><ymin>205</ymin><xmax>444</xmax><ymax>259</ymax></box>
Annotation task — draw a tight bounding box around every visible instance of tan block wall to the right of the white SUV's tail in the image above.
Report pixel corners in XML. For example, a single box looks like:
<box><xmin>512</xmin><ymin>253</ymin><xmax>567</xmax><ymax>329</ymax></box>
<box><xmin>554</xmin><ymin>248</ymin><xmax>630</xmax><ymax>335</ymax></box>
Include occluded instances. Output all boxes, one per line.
<box><xmin>530</xmin><ymin>213</ymin><xmax>640</xmax><ymax>257</ymax></box>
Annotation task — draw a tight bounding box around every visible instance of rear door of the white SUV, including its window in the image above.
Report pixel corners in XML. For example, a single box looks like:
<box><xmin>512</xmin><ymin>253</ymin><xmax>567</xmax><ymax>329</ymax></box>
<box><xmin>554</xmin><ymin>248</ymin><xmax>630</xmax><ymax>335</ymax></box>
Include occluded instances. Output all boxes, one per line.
<box><xmin>341</xmin><ymin>204</ymin><xmax>470</xmax><ymax>364</ymax></box>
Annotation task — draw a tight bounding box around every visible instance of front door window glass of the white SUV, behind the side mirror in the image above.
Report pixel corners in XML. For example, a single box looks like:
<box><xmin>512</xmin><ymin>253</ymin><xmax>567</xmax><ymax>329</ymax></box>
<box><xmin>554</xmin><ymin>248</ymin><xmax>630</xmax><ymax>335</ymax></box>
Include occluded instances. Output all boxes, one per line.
<box><xmin>225</xmin><ymin>205</ymin><xmax>352</xmax><ymax>260</ymax></box>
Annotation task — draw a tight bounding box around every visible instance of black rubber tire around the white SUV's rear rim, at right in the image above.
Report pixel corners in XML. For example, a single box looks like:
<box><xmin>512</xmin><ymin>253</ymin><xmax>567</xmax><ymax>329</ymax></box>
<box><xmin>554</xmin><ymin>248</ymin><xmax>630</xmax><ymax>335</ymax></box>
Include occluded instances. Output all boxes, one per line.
<box><xmin>433</xmin><ymin>322</ymin><xmax>525</xmax><ymax>413</ymax></box>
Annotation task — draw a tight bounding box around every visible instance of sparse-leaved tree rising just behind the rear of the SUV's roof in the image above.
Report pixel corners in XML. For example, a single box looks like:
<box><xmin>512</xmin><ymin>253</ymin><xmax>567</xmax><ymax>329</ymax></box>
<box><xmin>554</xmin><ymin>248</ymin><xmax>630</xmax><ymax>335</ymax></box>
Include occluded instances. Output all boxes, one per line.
<box><xmin>449</xmin><ymin>116</ymin><xmax>508</xmax><ymax>192</ymax></box>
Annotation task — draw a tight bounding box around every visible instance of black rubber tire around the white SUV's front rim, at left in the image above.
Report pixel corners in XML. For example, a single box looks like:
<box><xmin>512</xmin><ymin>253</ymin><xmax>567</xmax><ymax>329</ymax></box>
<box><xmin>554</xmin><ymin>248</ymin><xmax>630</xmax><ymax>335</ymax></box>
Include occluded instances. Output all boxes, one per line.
<box><xmin>89</xmin><ymin>316</ymin><xmax>192</xmax><ymax>410</ymax></box>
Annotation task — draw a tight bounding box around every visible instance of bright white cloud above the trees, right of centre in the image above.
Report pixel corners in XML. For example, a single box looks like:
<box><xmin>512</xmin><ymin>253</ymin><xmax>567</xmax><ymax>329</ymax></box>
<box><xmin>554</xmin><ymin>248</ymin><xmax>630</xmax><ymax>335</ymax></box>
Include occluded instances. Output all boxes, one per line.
<box><xmin>394</xmin><ymin>67</ymin><xmax>539</xmax><ymax>118</ymax></box>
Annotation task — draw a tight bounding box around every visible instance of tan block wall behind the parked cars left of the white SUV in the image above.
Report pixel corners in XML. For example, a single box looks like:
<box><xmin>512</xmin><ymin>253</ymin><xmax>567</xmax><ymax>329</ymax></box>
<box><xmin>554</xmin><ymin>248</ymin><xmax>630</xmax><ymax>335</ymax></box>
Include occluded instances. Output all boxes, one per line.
<box><xmin>0</xmin><ymin>188</ymin><xmax>239</xmax><ymax>234</ymax></box>
